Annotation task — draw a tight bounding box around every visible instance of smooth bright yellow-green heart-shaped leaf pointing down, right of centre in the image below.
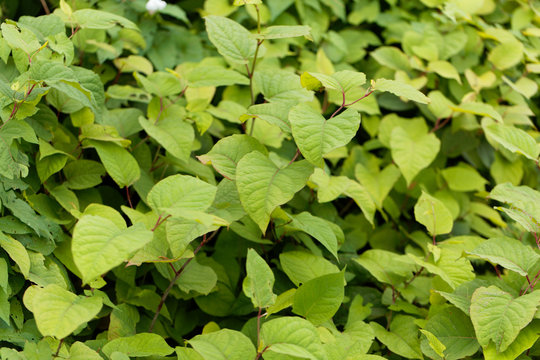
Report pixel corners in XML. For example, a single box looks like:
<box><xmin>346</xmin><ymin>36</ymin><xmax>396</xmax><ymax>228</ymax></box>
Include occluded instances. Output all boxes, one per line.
<box><xmin>390</xmin><ymin>127</ymin><xmax>441</xmax><ymax>185</ymax></box>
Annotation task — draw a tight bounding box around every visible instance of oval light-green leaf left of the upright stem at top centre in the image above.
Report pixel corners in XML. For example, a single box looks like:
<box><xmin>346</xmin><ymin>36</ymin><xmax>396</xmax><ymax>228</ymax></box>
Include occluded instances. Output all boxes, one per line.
<box><xmin>204</xmin><ymin>15</ymin><xmax>257</xmax><ymax>64</ymax></box>
